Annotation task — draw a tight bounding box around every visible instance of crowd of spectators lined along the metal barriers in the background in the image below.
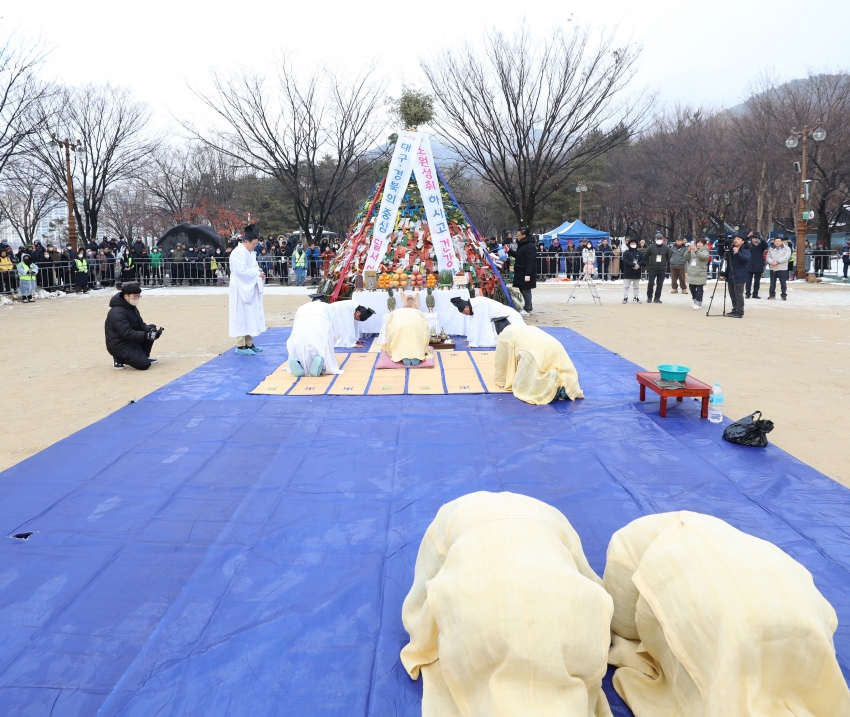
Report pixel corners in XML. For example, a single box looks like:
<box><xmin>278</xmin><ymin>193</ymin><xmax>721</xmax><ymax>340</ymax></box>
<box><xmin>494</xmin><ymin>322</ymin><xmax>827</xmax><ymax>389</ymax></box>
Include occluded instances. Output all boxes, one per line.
<box><xmin>0</xmin><ymin>224</ymin><xmax>850</xmax><ymax>309</ymax></box>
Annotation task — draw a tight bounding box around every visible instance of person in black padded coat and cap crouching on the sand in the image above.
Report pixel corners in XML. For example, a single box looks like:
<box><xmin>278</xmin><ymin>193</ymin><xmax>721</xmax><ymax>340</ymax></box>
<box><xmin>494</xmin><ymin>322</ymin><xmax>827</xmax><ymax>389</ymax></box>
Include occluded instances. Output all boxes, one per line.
<box><xmin>105</xmin><ymin>281</ymin><xmax>164</xmax><ymax>371</ymax></box>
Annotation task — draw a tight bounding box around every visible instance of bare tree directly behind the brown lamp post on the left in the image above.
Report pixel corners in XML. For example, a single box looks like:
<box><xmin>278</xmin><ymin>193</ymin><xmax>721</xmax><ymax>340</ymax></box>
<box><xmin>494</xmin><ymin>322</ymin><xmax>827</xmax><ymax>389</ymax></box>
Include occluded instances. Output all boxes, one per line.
<box><xmin>35</xmin><ymin>84</ymin><xmax>158</xmax><ymax>242</ymax></box>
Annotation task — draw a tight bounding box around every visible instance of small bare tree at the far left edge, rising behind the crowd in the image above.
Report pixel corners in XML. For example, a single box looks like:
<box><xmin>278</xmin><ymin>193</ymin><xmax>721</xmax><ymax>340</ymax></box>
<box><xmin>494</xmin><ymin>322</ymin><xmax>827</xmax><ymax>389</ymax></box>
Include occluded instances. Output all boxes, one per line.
<box><xmin>0</xmin><ymin>157</ymin><xmax>61</xmax><ymax>246</ymax></box>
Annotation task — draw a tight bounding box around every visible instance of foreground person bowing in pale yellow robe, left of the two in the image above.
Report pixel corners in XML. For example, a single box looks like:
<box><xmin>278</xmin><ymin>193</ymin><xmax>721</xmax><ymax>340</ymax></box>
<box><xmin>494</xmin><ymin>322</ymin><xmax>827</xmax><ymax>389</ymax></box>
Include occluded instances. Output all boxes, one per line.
<box><xmin>401</xmin><ymin>492</ymin><xmax>613</xmax><ymax>717</ymax></box>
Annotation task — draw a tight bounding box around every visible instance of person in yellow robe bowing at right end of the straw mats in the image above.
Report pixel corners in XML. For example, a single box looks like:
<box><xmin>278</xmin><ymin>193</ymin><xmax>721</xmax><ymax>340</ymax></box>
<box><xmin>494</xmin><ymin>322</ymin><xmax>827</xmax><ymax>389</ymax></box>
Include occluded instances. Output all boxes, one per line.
<box><xmin>495</xmin><ymin>324</ymin><xmax>584</xmax><ymax>405</ymax></box>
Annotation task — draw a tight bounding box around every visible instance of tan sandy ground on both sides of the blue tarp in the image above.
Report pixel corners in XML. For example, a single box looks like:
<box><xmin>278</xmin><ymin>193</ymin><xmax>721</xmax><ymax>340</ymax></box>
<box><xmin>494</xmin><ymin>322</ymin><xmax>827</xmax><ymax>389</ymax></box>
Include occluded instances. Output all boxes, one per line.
<box><xmin>0</xmin><ymin>282</ymin><xmax>850</xmax><ymax>486</ymax></box>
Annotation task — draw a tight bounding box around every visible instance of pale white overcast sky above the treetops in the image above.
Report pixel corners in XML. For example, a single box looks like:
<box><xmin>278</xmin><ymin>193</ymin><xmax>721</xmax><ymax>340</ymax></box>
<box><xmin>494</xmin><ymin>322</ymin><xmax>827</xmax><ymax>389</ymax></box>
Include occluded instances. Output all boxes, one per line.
<box><xmin>0</xmin><ymin>0</ymin><xmax>850</xmax><ymax>131</ymax></box>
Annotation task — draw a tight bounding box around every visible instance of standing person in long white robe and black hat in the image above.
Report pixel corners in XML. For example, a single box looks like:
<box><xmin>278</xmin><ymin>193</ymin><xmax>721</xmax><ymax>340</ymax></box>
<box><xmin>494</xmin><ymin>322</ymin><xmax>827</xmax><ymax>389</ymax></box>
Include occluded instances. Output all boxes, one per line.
<box><xmin>229</xmin><ymin>224</ymin><xmax>266</xmax><ymax>356</ymax></box>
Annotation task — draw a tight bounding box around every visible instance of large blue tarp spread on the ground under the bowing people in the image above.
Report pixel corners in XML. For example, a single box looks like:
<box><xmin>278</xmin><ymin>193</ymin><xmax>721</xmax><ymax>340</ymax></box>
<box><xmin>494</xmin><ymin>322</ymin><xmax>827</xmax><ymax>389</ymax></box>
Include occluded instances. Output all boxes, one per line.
<box><xmin>0</xmin><ymin>329</ymin><xmax>850</xmax><ymax>717</ymax></box>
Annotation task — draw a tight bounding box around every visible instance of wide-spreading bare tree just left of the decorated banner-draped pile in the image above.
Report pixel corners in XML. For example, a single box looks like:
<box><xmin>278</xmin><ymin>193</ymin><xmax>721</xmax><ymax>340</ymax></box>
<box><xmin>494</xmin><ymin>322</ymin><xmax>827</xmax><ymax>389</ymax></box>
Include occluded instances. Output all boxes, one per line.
<box><xmin>184</xmin><ymin>61</ymin><xmax>384</xmax><ymax>240</ymax></box>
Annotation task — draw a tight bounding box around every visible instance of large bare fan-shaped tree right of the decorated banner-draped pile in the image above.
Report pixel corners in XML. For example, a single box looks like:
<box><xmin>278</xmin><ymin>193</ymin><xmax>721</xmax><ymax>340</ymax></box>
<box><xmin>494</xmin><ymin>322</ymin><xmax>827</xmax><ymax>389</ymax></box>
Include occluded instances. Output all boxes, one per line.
<box><xmin>422</xmin><ymin>27</ymin><xmax>651</xmax><ymax>225</ymax></box>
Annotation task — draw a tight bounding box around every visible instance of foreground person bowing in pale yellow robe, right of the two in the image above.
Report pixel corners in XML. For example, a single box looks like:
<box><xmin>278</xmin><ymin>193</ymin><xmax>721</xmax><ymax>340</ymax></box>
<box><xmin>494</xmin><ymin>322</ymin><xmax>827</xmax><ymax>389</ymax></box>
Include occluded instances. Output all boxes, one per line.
<box><xmin>604</xmin><ymin>511</ymin><xmax>850</xmax><ymax>717</ymax></box>
